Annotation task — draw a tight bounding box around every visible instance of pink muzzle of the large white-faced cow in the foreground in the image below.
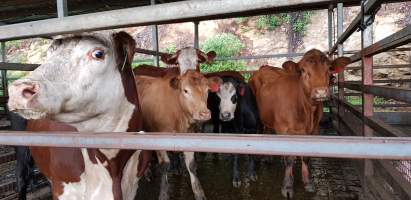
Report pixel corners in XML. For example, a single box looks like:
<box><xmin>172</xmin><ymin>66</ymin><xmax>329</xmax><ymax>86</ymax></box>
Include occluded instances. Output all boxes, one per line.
<box><xmin>8</xmin><ymin>80</ymin><xmax>45</xmax><ymax>119</ymax></box>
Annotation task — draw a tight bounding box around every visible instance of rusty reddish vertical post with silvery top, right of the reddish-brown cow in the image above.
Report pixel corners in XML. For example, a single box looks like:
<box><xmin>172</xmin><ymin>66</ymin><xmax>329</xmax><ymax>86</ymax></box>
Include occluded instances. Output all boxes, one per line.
<box><xmin>361</xmin><ymin>7</ymin><xmax>374</xmax><ymax>178</ymax></box>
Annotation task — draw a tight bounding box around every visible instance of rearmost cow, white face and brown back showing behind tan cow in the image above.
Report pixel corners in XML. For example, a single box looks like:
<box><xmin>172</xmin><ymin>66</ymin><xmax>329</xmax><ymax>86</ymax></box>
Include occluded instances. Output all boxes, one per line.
<box><xmin>133</xmin><ymin>47</ymin><xmax>216</xmax><ymax>77</ymax></box>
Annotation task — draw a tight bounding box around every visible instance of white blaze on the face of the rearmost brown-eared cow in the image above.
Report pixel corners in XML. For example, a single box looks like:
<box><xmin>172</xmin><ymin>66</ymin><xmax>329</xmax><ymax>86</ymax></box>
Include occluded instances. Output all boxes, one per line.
<box><xmin>177</xmin><ymin>47</ymin><xmax>199</xmax><ymax>74</ymax></box>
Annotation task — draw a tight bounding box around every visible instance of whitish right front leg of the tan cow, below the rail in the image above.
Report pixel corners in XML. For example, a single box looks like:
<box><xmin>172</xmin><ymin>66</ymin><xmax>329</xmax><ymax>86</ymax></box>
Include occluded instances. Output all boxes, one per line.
<box><xmin>184</xmin><ymin>152</ymin><xmax>206</xmax><ymax>200</ymax></box>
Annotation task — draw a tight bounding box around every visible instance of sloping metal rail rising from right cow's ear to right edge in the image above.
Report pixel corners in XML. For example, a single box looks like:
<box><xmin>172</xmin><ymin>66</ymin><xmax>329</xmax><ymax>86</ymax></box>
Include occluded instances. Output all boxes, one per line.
<box><xmin>350</xmin><ymin>25</ymin><xmax>411</xmax><ymax>62</ymax></box>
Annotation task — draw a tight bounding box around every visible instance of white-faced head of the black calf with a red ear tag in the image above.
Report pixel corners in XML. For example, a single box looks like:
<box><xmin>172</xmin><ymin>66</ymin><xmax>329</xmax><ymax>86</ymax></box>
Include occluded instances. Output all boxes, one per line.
<box><xmin>216</xmin><ymin>79</ymin><xmax>245</xmax><ymax>121</ymax></box>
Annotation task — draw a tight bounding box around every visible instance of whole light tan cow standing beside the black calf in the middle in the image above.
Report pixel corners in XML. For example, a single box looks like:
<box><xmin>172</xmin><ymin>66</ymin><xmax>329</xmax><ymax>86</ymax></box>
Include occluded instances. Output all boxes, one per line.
<box><xmin>136</xmin><ymin>70</ymin><xmax>221</xmax><ymax>200</ymax></box>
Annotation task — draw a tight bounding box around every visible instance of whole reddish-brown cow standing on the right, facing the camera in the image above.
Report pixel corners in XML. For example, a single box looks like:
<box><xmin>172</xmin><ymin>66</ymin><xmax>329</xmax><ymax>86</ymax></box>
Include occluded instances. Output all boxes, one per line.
<box><xmin>249</xmin><ymin>49</ymin><xmax>350</xmax><ymax>198</ymax></box>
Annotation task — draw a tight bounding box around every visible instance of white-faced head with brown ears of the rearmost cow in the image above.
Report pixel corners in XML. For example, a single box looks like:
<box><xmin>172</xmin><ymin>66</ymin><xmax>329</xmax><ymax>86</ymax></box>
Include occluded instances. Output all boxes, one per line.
<box><xmin>161</xmin><ymin>47</ymin><xmax>216</xmax><ymax>74</ymax></box>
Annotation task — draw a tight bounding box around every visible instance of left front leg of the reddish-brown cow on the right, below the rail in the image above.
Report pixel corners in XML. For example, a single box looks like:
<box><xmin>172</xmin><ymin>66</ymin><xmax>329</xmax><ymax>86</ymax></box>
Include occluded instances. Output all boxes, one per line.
<box><xmin>281</xmin><ymin>156</ymin><xmax>295</xmax><ymax>198</ymax></box>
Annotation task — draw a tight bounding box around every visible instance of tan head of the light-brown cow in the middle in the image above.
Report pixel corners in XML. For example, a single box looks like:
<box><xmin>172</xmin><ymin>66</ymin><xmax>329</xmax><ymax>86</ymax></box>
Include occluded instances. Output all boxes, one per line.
<box><xmin>170</xmin><ymin>70</ymin><xmax>222</xmax><ymax>121</ymax></box>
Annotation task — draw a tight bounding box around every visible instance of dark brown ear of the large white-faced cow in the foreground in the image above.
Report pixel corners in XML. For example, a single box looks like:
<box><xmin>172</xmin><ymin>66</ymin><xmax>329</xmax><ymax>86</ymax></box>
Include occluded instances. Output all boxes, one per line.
<box><xmin>114</xmin><ymin>31</ymin><xmax>136</xmax><ymax>64</ymax></box>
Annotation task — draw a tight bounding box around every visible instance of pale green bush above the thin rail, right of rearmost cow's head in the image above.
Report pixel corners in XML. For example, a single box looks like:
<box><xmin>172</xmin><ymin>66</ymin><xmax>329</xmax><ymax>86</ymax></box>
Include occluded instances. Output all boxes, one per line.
<box><xmin>201</xmin><ymin>33</ymin><xmax>244</xmax><ymax>57</ymax></box>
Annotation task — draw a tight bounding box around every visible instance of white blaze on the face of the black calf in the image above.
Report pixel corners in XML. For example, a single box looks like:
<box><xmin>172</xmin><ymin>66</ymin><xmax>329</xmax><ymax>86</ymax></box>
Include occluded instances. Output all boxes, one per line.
<box><xmin>217</xmin><ymin>82</ymin><xmax>238</xmax><ymax>121</ymax></box>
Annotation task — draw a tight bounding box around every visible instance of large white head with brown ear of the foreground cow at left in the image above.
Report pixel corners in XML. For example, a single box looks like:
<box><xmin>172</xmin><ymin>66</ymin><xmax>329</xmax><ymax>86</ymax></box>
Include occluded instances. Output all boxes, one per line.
<box><xmin>8</xmin><ymin>32</ymin><xmax>138</xmax><ymax>126</ymax></box>
